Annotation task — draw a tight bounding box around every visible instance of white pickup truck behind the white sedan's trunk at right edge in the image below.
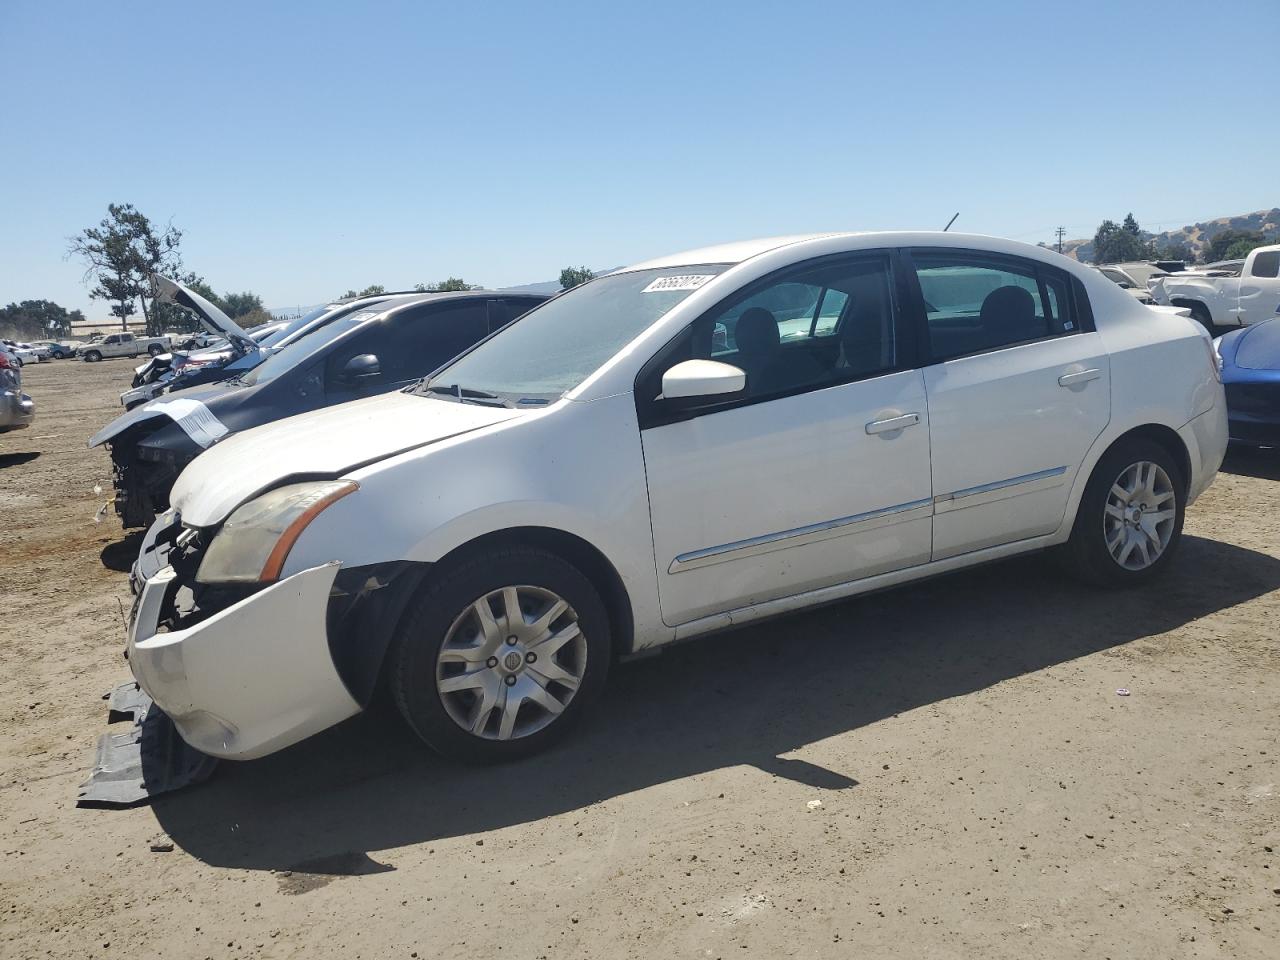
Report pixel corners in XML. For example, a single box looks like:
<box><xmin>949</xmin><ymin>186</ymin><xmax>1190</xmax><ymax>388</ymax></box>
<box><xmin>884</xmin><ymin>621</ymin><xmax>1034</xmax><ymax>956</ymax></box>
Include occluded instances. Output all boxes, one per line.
<box><xmin>1151</xmin><ymin>243</ymin><xmax>1280</xmax><ymax>332</ymax></box>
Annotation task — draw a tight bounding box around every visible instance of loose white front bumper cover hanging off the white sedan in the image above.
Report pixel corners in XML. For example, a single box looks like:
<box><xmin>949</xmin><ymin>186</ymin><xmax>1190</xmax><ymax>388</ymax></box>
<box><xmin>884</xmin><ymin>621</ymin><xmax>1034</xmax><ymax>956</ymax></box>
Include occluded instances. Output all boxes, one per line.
<box><xmin>128</xmin><ymin>562</ymin><xmax>360</xmax><ymax>760</ymax></box>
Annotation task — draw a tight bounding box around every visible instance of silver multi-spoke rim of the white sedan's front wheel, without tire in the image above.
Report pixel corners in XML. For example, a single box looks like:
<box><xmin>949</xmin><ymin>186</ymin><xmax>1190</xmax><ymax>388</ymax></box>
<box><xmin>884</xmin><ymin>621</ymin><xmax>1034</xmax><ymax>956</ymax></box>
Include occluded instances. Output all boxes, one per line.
<box><xmin>435</xmin><ymin>585</ymin><xmax>586</xmax><ymax>740</ymax></box>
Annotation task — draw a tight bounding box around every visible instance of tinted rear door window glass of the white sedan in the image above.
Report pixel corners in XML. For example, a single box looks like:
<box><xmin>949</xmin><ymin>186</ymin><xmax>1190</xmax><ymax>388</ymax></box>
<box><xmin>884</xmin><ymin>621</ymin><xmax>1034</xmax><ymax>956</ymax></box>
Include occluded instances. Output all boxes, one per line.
<box><xmin>913</xmin><ymin>251</ymin><xmax>1079</xmax><ymax>361</ymax></box>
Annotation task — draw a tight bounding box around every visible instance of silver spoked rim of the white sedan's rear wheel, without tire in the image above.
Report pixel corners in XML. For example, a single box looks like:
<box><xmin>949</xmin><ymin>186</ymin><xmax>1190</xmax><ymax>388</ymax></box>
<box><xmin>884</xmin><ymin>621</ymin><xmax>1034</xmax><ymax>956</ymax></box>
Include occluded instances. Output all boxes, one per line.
<box><xmin>1102</xmin><ymin>460</ymin><xmax>1178</xmax><ymax>571</ymax></box>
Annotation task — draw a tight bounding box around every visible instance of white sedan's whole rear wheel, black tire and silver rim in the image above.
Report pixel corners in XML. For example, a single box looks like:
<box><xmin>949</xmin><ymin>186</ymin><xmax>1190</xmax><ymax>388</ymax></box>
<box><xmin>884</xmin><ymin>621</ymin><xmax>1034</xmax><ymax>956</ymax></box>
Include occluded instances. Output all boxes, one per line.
<box><xmin>1065</xmin><ymin>438</ymin><xmax>1187</xmax><ymax>586</ymax></box>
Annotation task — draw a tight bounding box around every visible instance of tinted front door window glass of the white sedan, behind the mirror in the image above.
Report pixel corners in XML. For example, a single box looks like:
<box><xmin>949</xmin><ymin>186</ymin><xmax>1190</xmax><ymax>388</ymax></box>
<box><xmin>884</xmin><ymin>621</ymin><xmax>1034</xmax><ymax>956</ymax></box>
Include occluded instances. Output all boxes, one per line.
<box><xmin>691</xmin><ymin>257</ymin><xmax>897</xmax><ymax>399</ymax></box>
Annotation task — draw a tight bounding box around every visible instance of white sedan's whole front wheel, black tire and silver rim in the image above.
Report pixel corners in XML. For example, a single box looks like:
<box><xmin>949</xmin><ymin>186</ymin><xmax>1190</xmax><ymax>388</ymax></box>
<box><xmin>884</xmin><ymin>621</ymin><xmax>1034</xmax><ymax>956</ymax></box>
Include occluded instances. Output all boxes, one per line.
<box><xmin>388</xmin><ymin>547</ymin><xmax>612</xmax><ymax>763</ymax></box>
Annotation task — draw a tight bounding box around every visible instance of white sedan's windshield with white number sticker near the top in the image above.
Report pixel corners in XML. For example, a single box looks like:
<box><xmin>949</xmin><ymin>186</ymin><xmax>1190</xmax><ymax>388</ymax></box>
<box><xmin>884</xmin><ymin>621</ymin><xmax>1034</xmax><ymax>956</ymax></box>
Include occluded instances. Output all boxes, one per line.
<box><xmin>417</xmin><ymin>264</ymin><xmax>730</xmax><ymax>399</ymax></box>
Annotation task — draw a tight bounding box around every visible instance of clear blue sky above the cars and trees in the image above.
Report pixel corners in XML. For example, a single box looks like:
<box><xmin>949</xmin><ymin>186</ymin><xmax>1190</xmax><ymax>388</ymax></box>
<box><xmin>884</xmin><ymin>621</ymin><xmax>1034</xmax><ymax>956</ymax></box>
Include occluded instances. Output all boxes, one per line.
<box><xmin>0</xmin><ymin>0</ymin><xmax>1280</xmax><ymax>317</ymax></box>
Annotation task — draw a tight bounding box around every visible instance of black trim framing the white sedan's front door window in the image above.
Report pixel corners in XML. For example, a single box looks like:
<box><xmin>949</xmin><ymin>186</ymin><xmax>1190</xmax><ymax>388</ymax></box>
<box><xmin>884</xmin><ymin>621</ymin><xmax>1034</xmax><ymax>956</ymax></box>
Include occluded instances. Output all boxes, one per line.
<box><xmin>632</xmin><ymin>247</ymin><xmax>920</xmax><ymax>430</ymax></box>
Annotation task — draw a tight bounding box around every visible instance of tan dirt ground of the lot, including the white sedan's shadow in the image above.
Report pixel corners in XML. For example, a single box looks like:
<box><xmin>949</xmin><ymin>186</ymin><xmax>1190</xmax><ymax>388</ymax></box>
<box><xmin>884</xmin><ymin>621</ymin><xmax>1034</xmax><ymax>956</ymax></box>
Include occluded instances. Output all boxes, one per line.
<box><xmin>0</xmin><ymin>361</ymin><xmax>1280</xmax><ymax>960</ymax></box>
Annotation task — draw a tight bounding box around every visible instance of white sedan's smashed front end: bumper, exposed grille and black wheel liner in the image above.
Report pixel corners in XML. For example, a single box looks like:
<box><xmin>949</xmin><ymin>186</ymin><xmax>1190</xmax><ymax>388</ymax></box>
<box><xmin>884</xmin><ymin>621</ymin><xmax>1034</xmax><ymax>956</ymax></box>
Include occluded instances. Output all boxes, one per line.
<box><xmin>127</xmin><ymin>511</ymin><xmax>428</xmax><ymax>759</ymax></box>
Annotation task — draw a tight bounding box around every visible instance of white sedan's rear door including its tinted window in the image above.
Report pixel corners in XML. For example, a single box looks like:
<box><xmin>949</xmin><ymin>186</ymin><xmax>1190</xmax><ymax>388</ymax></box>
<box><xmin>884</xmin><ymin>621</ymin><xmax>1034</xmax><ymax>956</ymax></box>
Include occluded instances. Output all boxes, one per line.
<box><xmin>909</xmin><ymin>250</ymin><xmax>1111</xmax><ymax>559</ymax></box>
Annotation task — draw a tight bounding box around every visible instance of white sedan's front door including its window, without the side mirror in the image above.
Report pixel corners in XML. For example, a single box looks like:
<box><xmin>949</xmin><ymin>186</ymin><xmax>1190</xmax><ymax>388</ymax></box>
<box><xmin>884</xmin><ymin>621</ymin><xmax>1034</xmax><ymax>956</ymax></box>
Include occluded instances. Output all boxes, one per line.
<box><xmin>637</xmin><ymin>256</ymin><xmax>932</xmax><ymax>625</ymax></box>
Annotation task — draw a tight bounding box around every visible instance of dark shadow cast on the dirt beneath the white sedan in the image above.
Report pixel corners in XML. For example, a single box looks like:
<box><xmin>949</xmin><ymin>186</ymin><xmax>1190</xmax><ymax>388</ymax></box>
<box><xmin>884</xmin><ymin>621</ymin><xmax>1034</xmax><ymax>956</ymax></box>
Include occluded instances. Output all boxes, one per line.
<box><xmin>155</xmin><ymin>536</ymin><xmax>1280</xmax><ymax>873</ymax></box>
